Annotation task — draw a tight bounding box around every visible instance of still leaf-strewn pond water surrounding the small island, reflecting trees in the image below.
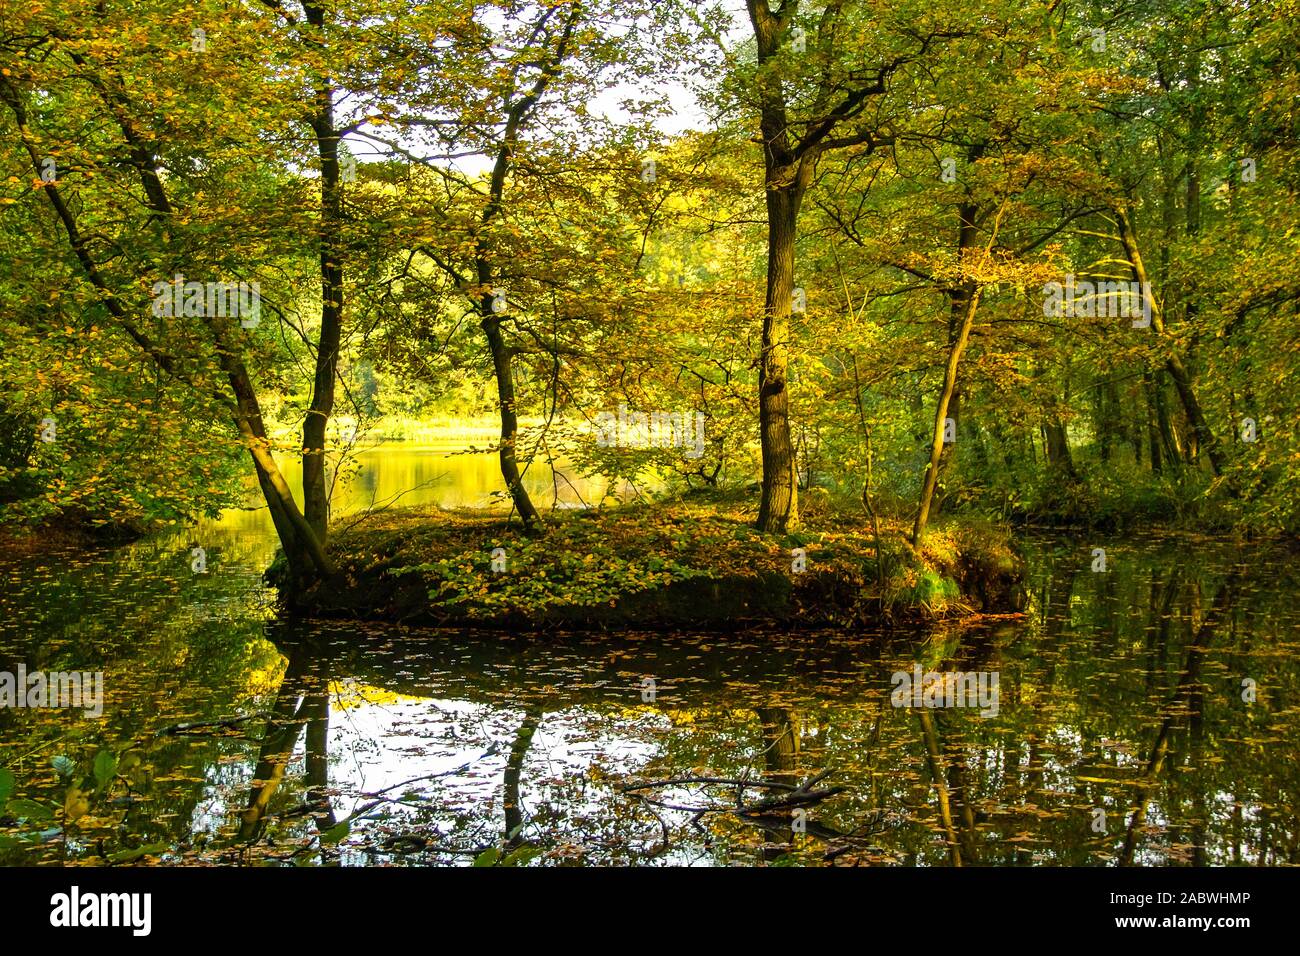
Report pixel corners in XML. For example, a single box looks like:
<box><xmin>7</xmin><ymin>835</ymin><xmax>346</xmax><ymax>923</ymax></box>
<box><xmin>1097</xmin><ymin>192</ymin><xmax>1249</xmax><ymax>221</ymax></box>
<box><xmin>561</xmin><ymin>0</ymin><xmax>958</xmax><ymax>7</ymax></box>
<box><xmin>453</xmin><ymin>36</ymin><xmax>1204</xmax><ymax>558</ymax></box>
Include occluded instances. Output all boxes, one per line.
<box><xmin>0</xmin><ymin>447</ymin><xmax>1300</xmax><ymax>866</ymax></box>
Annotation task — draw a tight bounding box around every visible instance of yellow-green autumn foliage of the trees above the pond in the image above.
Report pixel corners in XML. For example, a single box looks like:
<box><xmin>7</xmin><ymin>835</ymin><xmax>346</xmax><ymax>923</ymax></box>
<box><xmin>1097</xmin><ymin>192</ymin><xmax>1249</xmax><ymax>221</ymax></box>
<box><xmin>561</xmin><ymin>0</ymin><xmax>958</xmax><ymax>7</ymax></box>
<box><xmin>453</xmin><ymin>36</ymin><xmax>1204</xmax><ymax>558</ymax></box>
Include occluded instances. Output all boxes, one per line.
<box><xmin>0</xmin><ymin>0</ymin><xmax>1300</xmax><ymax>554</ymax></box>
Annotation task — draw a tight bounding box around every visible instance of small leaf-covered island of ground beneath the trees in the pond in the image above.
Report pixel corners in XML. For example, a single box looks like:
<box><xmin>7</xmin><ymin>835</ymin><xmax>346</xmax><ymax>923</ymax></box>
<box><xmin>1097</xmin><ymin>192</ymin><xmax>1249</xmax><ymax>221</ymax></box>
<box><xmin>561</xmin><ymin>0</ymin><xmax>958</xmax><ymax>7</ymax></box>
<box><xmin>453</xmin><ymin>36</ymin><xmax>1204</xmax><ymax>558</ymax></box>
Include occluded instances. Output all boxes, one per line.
<box><xmin>289</xmin><ymin>501</ymin><xmax>1023</xmax><ymax>631</ymax></box>
